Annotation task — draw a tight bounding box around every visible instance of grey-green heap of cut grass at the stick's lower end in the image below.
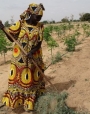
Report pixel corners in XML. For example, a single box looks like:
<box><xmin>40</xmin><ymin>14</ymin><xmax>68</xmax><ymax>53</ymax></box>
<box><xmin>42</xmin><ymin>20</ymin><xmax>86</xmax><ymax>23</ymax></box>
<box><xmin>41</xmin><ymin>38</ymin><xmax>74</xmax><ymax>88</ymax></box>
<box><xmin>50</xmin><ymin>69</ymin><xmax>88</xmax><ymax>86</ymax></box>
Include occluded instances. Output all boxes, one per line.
<box><xmin>35</xmin><ymin>92</ymin><xmax>85</xmax><ymax>114</ymax></box>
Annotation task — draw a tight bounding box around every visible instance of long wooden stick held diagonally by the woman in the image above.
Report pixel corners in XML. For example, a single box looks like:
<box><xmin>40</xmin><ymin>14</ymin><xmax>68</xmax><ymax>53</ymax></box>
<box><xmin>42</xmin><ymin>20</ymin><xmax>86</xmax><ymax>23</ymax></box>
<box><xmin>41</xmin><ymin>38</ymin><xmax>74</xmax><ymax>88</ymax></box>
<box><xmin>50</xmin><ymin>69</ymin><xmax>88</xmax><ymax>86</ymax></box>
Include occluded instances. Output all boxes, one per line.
<box><xmin>3</xmin><ymin>27</ymin><xmax>57</xmax><ymax>91</ymax></box>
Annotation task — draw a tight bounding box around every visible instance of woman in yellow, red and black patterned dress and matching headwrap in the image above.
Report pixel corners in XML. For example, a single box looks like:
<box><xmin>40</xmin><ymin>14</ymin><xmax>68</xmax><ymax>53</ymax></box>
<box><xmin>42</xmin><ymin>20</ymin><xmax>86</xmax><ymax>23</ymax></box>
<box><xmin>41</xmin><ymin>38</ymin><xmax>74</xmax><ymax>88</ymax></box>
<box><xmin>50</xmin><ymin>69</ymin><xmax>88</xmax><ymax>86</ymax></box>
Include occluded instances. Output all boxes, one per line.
<box><xmin>0</xmin><ymin>3</ymin><xmax>45</xmax><ymax>110</ymax></box>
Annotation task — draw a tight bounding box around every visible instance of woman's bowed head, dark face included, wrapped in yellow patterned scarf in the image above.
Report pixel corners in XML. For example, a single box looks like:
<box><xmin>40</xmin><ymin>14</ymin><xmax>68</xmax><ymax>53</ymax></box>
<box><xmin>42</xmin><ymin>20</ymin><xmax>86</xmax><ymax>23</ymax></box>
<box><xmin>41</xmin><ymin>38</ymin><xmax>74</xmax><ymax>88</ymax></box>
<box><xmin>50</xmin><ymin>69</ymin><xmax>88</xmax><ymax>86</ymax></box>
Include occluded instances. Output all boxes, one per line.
<box><xmin>20</xmin><ymin>3</ymin><xmax>45</xmax><ymax>21</ymax></box>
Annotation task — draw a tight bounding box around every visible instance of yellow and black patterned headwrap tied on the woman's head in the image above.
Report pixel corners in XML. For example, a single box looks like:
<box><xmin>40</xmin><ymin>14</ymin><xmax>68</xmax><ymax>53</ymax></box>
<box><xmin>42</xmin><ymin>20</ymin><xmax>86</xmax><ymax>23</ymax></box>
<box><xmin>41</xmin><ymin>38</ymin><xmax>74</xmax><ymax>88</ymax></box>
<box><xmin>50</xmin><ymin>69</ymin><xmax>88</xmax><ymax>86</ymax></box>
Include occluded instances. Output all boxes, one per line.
<box><xmin>20</xmin><ymin>3</ymin><xmax>45</xmax><ymax>19</ymax></box>
